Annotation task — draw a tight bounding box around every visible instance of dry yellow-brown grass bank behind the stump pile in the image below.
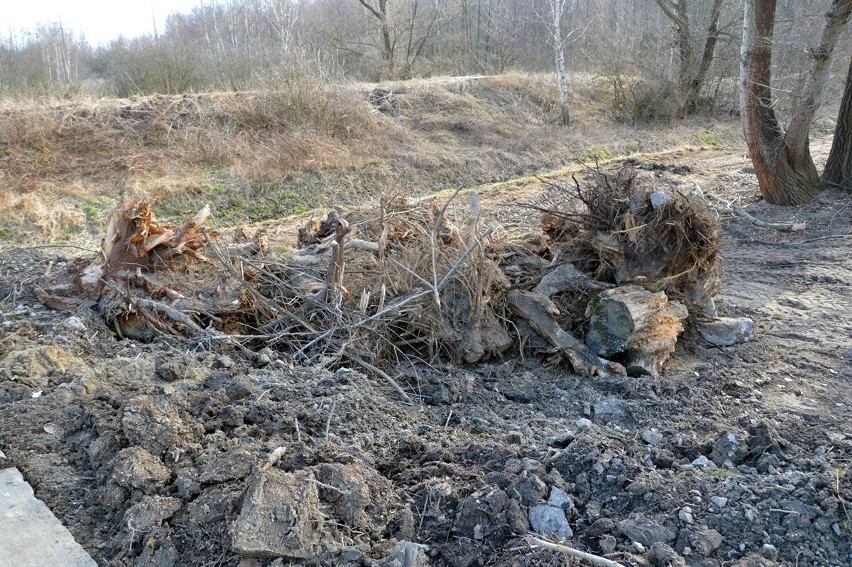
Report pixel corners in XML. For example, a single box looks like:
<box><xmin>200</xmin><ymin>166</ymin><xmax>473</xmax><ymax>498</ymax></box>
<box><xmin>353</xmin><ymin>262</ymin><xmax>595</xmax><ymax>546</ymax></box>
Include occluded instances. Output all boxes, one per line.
<box><xmin>0</xmin><ymin>74</ymin><xmax>739</xmax><ymax>243</ymax></box>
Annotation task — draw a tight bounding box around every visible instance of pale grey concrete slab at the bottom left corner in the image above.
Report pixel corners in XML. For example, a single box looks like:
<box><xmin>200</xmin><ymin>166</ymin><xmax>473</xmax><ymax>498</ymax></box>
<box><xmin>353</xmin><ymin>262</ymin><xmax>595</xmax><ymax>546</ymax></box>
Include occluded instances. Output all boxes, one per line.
<box><xmin>0</xmin><ymin>468</ymin><xmax>97</xmax><ymax>567</ymax></box>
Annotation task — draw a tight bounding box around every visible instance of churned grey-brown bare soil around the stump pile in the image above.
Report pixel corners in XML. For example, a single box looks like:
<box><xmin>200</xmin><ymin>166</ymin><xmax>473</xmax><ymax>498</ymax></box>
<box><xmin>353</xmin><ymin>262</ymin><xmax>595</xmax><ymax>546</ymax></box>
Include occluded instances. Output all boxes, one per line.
<box><xmin>0</xmin><ymin>142</ymin><xmax>852</xmax><ymax>567</ymax></box>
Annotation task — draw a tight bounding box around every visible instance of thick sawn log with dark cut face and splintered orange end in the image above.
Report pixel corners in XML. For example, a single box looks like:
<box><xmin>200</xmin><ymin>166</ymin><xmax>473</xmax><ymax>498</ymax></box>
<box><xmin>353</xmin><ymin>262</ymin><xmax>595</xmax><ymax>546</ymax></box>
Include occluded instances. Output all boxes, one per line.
<box><xmin>586</xmin><ymin>285</ymin><xmax>688</xmax><ymax>377</ymax></box>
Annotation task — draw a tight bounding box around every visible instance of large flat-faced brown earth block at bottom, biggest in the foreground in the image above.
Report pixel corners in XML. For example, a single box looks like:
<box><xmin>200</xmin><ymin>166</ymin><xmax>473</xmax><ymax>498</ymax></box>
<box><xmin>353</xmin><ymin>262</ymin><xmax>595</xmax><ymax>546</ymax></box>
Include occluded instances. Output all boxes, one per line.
<box><xmin>231</xmin><ymin>469</ymin><xmax>323</xmax><ymax>559</ymax></box>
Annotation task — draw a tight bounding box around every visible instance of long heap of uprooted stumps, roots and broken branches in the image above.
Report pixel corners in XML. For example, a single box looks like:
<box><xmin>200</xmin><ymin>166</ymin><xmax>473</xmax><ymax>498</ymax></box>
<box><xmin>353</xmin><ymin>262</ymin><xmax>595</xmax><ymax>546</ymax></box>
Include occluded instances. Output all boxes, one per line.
<box><xmin>39</xmin><ymin>169</ymin><xmax>742</xmax><ymax>384</ymax></box>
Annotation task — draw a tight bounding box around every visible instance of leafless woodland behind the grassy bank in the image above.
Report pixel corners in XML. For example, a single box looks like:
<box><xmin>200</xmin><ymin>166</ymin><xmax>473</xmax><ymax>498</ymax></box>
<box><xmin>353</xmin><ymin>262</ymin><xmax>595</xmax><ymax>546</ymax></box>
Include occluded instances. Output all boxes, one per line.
<box><xmin>0</xmin><ymin>0</ymin><xmax>852</xmax><ymax>121</ymax></box>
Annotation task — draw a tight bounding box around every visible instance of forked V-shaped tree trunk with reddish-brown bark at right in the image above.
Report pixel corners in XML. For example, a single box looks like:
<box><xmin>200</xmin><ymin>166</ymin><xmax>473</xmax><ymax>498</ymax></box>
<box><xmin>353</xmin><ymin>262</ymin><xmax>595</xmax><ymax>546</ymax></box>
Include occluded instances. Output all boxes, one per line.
<box><xmin>740</xmin><ymin>0</ymin><xmax>852</xmax><ymax>205</ymax></box>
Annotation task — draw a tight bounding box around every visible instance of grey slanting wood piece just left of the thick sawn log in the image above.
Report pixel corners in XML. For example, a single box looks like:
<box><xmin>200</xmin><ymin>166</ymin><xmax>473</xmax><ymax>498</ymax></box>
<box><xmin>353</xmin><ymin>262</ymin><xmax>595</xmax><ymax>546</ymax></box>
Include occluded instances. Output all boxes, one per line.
<box><xmin>506</xmin><ymin>290</ymin><xmax>625</xmax><ymax>376</ymax></box>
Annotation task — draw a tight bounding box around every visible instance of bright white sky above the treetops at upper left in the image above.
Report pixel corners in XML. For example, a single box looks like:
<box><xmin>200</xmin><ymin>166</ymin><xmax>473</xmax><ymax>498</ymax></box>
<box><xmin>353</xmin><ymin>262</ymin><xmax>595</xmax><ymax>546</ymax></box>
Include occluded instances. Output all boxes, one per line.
<box><xmin>6</xmin><ymin>0</ymin><xmax>202</xmax><ymax>46</ymax></box>
